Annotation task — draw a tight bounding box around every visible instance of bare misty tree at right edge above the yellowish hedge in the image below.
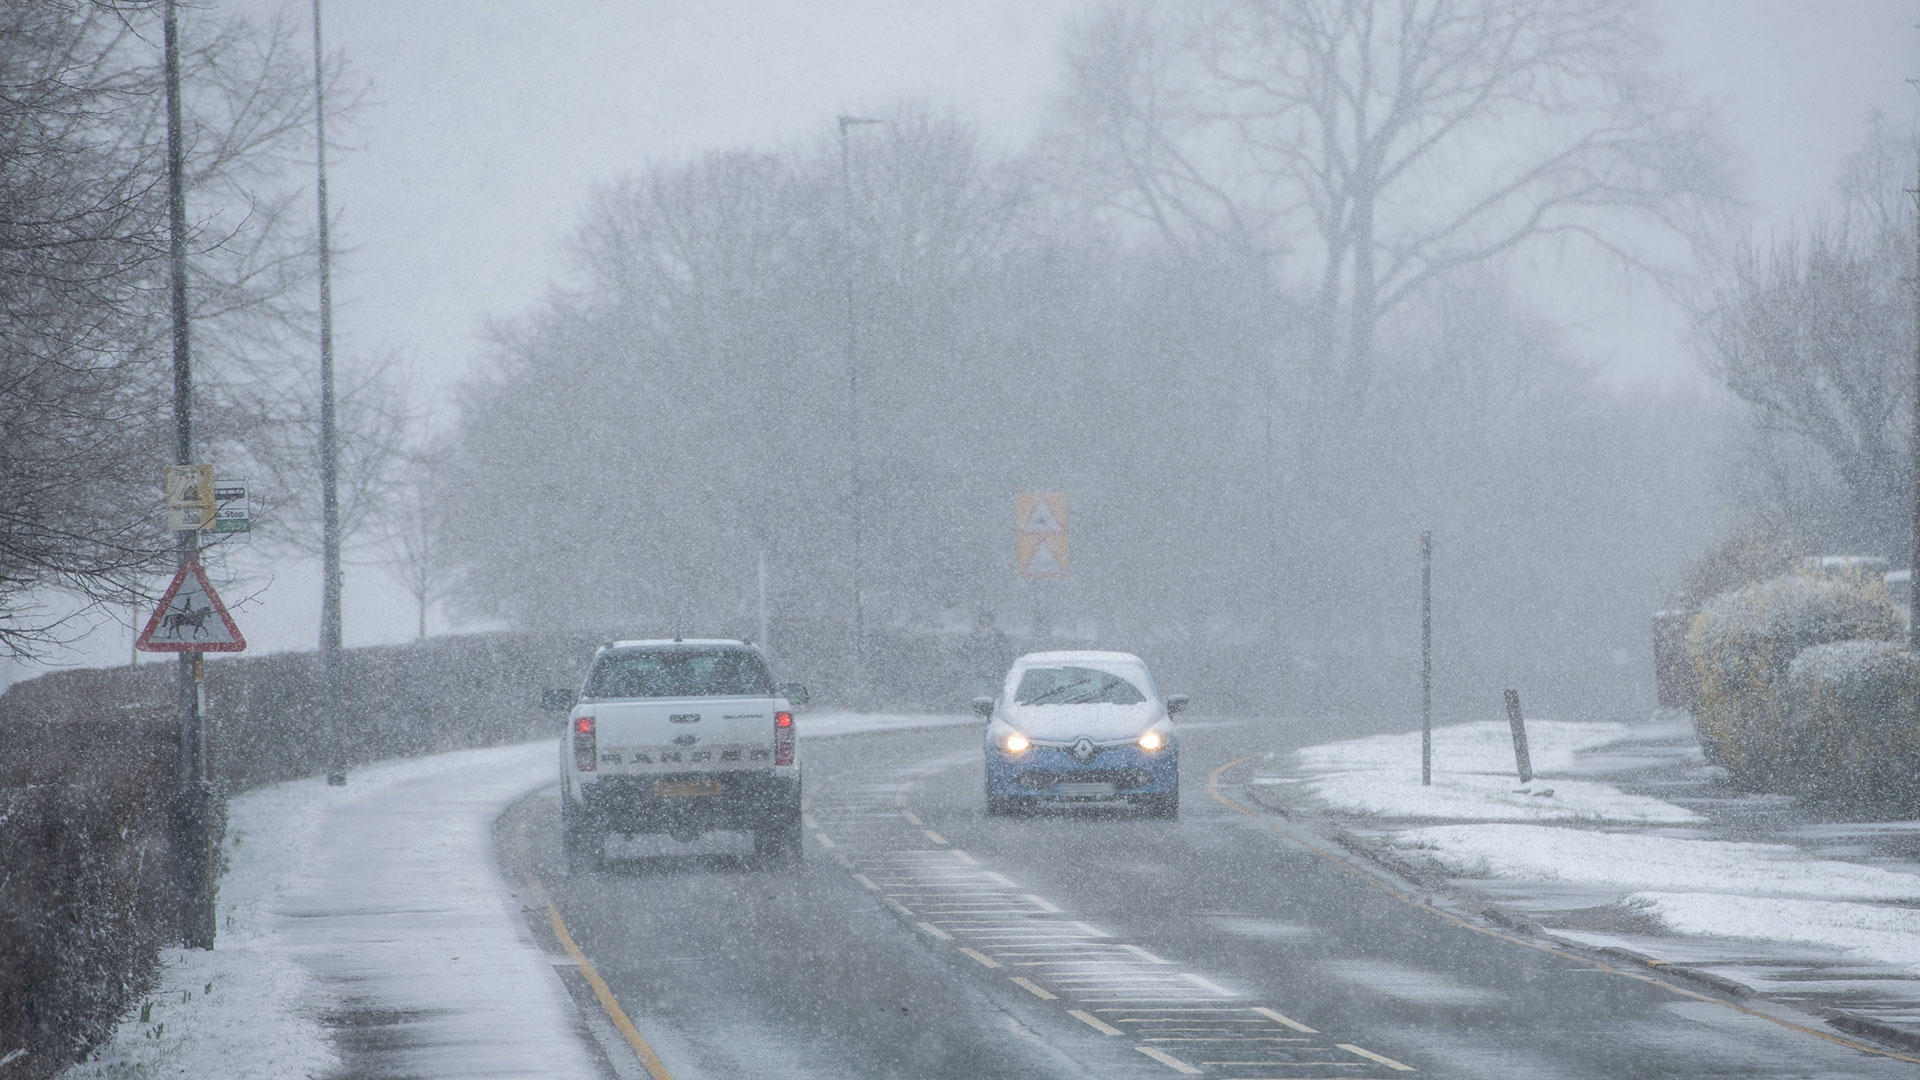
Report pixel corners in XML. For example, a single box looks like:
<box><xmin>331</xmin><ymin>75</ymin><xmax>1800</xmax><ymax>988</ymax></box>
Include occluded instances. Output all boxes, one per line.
<box><xmin>1697</xmin><ymin>113</ymin><xmax>1920</xmax><ymax>553</ymax></box>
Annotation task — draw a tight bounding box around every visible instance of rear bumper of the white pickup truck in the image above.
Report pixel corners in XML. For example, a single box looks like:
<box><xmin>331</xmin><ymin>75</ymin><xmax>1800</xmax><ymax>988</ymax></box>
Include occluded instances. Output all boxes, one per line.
<box><xmin>582</xmin><ymin>773</ymin><xmax>801</xmax><ymax>832</ymax></box>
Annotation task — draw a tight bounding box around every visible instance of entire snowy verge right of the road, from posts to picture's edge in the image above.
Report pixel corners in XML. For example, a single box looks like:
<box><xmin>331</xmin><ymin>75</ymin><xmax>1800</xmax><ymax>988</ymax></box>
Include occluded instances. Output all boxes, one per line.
<box><xmin>1256</xmin><ymin>721</ymin><xmax>1920</xmax><ymax>972</ymax></box>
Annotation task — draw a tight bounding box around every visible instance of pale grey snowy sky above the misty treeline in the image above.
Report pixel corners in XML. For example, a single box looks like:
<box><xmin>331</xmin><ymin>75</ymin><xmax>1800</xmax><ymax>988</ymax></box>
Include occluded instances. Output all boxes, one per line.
<box><xmin>18</xmin><ymin>0</ymin><xmax>1920</xmax><ymax>676</ymax></box>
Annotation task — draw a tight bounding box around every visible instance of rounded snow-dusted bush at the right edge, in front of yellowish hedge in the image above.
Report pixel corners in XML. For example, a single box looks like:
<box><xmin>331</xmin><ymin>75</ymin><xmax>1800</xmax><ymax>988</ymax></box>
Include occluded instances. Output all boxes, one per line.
<box><xmin>1782</xmin><ymin>642</ymin><xmax>1920</xmax><ymax>815</ymax></box>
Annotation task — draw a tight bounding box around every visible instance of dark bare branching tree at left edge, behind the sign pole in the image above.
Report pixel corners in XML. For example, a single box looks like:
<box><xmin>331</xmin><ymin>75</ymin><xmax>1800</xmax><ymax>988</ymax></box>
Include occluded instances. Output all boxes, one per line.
<box><xmin>0</xmin><ymin>0</ymin><xmax>351</xmax><ymax>655</ymax></box>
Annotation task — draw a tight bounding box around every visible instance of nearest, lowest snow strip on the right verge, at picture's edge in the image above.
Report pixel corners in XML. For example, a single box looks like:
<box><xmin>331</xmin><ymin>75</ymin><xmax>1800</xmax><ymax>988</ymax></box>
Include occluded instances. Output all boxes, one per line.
<box><xmin>1626</xmin><ymin>892</ymin><xmax>1920</xmax><ymax>972</ymax></box>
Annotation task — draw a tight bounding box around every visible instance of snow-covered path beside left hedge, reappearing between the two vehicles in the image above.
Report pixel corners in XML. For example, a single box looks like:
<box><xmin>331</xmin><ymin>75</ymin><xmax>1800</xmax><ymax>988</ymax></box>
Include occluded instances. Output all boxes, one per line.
<box><xmin>61</xmin><ymin>711</ymin><xmax>979</xmax><ymax>1080</ymax></box>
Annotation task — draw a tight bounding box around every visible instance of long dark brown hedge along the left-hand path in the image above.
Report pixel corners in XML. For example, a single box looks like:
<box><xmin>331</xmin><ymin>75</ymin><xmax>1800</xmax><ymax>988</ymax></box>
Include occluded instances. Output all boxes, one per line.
<box><xmin>0</xmin><ymin>634</ymin><xmax>595</xmax><ymax>1080</ymax></box>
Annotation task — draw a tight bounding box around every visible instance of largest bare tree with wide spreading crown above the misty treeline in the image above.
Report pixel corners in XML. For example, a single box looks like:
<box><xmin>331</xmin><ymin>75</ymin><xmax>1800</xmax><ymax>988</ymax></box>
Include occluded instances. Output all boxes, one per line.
<box><xmin>1066</xmin><ymin>0</ymin><xmax>1724</xmax><ymax>392</ymax></box>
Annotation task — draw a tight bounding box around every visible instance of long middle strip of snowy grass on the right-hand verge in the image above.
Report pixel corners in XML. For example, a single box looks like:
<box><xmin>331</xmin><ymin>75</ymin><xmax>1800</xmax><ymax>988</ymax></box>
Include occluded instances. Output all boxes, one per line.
<box><xmin>1392</xmin><ymin>824</ymin><xmax>1920</xmax><ymax>901</ymax></box>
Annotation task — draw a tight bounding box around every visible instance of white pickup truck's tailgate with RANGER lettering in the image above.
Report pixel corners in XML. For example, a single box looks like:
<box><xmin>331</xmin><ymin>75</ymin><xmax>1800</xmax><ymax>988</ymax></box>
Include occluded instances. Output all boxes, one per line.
<box><xmin>574</xmin><ymin>698</ymin><xmax>783</xmax><ymax>774</ymax></box>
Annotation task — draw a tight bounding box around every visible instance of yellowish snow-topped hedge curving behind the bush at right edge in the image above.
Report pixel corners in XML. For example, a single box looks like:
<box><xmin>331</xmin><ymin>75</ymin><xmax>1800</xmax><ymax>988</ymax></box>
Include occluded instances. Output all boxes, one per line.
<box><xmin>1688</xmin><ymin>573</ymin><xmax>1905</xmax><ymax>790</ymax></box>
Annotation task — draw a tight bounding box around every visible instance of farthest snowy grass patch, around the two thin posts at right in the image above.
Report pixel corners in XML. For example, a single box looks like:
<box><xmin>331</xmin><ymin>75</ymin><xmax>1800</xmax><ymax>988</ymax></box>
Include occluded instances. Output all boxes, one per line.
<box><xmin>1290</xmin><ymin>721</ymin><xmax>1697</xmax><ymax>824</ymax></box>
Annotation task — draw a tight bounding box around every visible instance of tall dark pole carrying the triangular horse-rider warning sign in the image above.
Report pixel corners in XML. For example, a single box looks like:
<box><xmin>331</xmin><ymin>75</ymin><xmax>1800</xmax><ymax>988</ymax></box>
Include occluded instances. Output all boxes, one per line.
<box><xmin>163</xmin><ymin>0</ymin><xmax>213</xmax><ymax>949</ymax></box>
